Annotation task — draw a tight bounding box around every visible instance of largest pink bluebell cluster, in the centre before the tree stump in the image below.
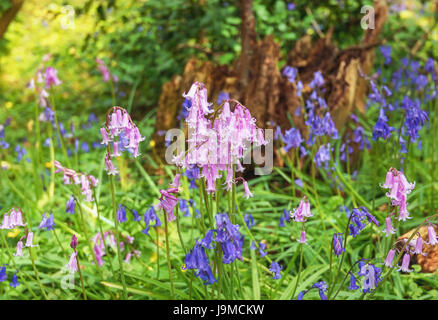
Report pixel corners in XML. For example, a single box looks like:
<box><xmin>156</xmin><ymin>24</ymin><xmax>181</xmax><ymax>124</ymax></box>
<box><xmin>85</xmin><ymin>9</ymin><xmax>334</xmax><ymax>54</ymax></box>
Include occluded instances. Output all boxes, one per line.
<box><xmin>173</xmin><ymin>82</ymin><xmax>267</xmax><ymax>197</ymax></box>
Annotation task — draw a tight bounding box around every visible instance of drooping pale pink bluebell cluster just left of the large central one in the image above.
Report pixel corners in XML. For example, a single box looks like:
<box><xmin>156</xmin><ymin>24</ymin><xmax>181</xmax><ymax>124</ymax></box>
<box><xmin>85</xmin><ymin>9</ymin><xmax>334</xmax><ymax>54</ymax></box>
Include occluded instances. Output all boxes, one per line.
<box><xmin>100</xmin><ymin>107</ymin><xmax>145</xmax><ymax>175</ymax></box>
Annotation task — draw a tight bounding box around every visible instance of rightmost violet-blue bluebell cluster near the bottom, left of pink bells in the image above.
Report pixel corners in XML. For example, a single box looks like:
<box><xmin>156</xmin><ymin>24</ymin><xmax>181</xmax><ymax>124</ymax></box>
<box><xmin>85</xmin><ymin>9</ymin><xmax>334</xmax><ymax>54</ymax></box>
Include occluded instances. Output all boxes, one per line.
<box><xmin>348</xmin><ymin>259</ymin><xmax>382</xmax><ymax>293</ymax></box>
